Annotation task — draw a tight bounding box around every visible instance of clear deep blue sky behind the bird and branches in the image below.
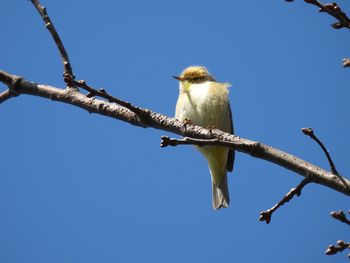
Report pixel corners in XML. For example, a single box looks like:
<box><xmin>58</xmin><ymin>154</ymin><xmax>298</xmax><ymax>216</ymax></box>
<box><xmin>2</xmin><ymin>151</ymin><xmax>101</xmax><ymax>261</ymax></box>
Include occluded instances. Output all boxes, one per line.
<box><xmin>0</xmin><ymin>0</ymin><xmax>350</xmax><ymax>263</ymax></box>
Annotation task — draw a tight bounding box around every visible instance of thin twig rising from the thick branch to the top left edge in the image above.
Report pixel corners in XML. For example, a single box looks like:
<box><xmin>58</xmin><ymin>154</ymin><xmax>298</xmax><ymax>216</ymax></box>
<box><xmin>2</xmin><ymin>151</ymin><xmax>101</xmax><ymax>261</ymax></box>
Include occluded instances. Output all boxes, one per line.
<box><xmin>31</xmin><ymin>0</ymin><xmax>75</xmax><ymax>87</ymax></box>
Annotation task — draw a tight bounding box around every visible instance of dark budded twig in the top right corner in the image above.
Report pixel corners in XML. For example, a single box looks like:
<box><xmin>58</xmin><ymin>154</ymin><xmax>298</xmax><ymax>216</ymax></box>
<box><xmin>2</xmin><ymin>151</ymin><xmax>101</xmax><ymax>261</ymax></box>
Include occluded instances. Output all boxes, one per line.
<box><xmin>286</xmin><ymin>0</ymin><xmax>350</xmax><ymax>29</ymax></box>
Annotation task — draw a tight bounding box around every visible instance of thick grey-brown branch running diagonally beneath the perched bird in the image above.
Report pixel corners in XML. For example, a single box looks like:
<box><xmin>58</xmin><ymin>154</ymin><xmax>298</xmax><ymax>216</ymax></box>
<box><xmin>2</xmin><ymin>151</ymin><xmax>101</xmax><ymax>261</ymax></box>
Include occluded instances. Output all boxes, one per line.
<box><xmin>0</xmin><ymin>70</ymin><xmax>350</xmax><ymax>198</ymax></box>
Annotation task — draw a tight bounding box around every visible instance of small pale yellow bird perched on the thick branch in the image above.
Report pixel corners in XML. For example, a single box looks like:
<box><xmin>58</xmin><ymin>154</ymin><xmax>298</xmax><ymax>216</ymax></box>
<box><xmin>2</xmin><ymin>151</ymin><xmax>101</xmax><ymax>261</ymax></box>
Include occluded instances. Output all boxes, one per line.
<box><xmin>173</xmin><ymin>66</ymin><xmax>235</xmax><ymax>210</ymax></box>
